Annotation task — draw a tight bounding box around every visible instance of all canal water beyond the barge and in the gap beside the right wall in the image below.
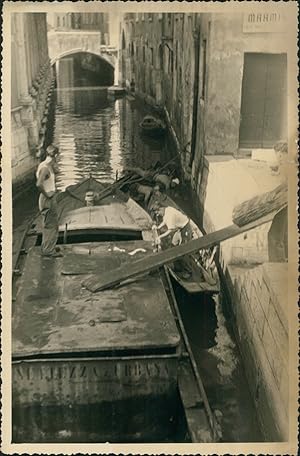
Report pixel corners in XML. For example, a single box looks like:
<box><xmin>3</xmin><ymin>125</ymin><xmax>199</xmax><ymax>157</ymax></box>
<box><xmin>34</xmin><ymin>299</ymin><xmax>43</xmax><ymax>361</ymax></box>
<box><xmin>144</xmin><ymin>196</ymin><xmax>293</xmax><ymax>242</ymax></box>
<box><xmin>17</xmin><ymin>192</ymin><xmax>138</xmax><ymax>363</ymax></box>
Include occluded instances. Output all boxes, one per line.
<box><xmin>13</xmin><ymin>87</ymin><xmax>262</xmax><ymax>442</ymax></box>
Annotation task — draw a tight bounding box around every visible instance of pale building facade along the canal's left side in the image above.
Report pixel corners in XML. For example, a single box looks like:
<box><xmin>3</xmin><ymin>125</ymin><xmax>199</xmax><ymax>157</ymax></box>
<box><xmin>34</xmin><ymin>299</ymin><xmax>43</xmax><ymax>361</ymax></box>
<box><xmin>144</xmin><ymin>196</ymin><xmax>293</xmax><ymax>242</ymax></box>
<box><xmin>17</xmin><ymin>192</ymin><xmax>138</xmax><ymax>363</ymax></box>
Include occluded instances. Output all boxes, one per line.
<box><xmin>11</xmin><ymin>13</ymin><xmax>52</xmax><ymax>195</ymax></box>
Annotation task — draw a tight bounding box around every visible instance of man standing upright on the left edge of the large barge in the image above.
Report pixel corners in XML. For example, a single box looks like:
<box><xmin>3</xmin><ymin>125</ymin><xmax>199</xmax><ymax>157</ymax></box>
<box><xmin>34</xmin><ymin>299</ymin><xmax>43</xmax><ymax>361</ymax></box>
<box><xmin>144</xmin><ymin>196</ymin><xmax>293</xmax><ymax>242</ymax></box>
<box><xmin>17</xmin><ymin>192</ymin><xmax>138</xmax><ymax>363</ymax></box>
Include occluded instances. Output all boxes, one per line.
<box><xmin>36</xmin><ymin>145</ymin><xmax>63</xmax><ymax>258</ymax></box>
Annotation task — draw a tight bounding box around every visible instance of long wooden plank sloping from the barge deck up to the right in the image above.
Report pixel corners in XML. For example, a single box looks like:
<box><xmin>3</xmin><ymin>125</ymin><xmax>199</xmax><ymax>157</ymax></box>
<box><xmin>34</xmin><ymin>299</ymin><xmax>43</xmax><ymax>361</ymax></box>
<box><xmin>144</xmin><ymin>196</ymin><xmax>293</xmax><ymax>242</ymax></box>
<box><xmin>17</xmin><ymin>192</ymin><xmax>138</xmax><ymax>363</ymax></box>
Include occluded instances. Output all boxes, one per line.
<box><xmin>82</xmin><ymin>214</ymin><xmax>274</xmax><ymax>292</ymax></box>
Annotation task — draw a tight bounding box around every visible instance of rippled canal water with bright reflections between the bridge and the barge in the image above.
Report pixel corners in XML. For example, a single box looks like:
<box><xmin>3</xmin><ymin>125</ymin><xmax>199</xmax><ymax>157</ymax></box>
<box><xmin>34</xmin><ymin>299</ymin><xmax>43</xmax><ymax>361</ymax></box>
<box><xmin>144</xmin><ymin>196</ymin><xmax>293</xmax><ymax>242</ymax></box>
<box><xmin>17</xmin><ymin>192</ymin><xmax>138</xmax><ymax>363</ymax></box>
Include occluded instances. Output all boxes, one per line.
<box><xmin>54</xmin><ymin>87</ymin><xmax>171</xmax><ymax>190</ymax></box>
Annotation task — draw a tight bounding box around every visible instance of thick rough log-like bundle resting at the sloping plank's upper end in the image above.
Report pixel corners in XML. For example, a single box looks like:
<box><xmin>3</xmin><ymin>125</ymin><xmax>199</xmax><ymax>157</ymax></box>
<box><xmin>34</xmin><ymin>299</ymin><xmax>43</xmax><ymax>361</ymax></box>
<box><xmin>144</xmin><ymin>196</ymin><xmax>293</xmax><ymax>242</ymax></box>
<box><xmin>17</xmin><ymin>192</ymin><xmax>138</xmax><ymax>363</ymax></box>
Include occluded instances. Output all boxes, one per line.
<box><xmin>232</xmin><ymin>183</ymin><xmax>288</xmax><ymax>226</ymax></box>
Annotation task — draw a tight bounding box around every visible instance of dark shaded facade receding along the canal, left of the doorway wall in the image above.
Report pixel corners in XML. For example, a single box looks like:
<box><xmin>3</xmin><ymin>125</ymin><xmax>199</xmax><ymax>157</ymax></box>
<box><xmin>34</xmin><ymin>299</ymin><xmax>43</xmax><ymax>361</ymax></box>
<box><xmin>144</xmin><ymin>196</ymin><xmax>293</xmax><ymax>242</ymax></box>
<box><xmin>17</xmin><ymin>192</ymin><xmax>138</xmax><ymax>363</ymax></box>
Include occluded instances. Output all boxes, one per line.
<box><xmin>120</xmin><ymin>13</ymin><xmax>200</xmax><ymax>173</ymax></box>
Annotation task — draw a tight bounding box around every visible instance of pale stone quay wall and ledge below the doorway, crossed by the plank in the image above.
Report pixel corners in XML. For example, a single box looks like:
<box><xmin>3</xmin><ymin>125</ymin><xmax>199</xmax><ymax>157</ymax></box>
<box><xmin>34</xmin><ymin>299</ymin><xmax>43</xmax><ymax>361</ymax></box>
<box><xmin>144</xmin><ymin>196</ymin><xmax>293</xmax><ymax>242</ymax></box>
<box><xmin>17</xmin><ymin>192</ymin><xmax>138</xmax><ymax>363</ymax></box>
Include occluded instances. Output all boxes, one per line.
<box><xmin>197</xmin><ymin>155</ymin><xmax>289</xmax><ymax>441</ymax></box>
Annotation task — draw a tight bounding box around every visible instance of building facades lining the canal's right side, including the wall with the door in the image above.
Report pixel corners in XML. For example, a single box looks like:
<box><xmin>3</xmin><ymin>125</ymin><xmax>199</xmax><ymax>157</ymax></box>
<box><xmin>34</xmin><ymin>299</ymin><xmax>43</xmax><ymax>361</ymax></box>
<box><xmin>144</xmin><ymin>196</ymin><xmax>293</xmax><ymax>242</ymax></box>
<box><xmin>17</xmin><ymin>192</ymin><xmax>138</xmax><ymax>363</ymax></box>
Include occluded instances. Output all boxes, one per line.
<box><xmin>120</xmin><ymin>11</ymin><xmax>287</xmax><ymax>180</ymax></box>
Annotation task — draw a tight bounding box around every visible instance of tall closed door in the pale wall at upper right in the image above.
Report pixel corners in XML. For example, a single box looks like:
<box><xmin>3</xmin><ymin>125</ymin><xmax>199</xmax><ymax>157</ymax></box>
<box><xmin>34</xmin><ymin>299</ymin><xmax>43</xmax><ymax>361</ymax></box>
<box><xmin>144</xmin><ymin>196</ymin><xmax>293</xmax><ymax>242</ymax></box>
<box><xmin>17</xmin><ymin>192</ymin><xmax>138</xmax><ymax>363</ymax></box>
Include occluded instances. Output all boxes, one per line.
<box><xmin>240</xmin><ymin>53</ymin><xmax>287</xmax><ymax>148</ymax></box>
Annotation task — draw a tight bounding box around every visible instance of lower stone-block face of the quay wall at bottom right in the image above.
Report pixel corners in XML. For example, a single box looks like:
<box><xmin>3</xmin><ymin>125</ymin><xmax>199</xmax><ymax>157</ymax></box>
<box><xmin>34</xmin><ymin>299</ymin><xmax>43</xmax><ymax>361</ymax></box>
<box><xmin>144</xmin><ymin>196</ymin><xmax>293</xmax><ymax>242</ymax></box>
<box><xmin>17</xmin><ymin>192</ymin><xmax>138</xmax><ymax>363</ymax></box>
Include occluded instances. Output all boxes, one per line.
<box><xmin>226</xmin><ymin>263</ymin><xmax>289</xmax><ymax>441</ymax></box>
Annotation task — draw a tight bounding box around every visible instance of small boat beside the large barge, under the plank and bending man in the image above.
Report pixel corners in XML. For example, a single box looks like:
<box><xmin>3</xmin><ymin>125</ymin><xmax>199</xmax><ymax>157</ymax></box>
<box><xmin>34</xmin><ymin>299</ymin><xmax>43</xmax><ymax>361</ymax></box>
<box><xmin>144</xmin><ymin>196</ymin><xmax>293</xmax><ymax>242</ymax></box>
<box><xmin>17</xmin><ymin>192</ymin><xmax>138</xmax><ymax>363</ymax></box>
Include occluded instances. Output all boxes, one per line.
<box><xmin>148</xmin><ymin>194</ymin><xmax>220</xmax><ymax>294</ymax></box>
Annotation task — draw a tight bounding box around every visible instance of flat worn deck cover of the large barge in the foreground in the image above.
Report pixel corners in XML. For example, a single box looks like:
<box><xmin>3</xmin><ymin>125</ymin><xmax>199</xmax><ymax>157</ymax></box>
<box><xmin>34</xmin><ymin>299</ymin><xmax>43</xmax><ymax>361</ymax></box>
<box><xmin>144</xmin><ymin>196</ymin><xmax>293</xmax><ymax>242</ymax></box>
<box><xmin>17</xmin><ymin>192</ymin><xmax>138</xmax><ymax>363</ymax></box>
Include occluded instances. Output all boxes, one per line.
<box><xmin>12</xmin><ymin>246</ymin><xmax>180</xmax><ymax>357</ymax></box>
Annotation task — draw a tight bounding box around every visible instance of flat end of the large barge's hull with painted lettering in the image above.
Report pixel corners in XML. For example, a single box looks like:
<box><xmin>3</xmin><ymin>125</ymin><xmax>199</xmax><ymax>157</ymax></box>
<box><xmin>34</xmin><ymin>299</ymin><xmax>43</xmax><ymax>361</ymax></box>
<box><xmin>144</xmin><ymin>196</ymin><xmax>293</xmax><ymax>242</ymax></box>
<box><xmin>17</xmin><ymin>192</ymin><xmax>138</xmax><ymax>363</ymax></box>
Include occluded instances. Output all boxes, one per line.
<box><xmin>12</xmin><ymin>355</ymin><xmax>178</xmax><ymax>443</ymax></box>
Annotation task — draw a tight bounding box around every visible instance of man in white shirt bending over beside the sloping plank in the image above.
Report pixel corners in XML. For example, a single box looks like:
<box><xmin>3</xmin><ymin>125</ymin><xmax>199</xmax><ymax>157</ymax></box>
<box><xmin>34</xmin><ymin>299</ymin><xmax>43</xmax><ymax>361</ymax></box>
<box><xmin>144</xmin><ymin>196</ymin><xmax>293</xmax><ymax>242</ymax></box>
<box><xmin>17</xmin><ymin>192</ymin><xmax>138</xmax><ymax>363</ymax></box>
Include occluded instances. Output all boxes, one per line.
<box><xmin>157</xmin><ymin>206</ymin><xmax>189</xmax><ymax>245</ymax></box>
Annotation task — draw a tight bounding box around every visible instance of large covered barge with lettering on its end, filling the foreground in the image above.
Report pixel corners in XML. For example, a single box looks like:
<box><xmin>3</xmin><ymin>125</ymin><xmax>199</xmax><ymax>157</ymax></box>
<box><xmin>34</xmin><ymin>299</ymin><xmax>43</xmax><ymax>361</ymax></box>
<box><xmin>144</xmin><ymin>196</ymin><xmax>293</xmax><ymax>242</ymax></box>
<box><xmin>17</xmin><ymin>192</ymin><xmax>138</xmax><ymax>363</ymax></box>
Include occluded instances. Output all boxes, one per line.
<box><xmin>12</xmin><ymin>178</ymin><xmax>216</xmax><ymax>443</ymax></box>
